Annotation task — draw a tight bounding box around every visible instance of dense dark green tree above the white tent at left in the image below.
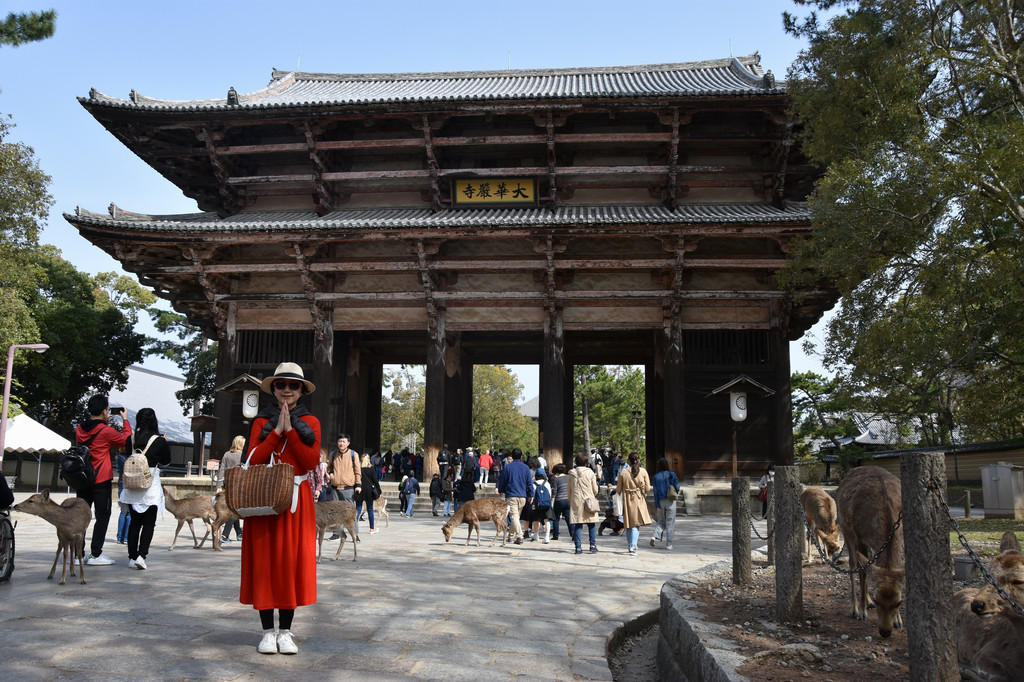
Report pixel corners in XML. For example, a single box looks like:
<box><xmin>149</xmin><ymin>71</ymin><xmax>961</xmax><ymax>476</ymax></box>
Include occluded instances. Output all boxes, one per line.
<box><xmin>20</xmin><ymin>246</ymin><xmax>145</xmax><ymax>435</ymax></box>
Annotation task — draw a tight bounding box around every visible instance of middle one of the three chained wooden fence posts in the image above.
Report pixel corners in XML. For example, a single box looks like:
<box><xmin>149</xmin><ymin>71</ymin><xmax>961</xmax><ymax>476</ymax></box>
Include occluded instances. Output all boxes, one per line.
<box><xmin>768</xmin><ymin>466</ymin><xmax>806</xmax><ymax>623</ymax></box>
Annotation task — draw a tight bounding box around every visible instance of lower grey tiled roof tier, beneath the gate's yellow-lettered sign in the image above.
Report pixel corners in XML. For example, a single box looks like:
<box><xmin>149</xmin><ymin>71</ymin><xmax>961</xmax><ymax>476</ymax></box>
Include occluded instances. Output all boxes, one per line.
<box><xmin>65</xmin><ymin>203</ymin><xmax>811</xmax><ymax>233</ymax></box>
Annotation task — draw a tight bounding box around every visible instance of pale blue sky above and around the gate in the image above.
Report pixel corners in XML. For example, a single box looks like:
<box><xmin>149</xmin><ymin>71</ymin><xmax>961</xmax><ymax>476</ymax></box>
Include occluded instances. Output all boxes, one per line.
<box><xmin>0</xmin><ymin>0</ymin><xmax>831</xmax><ymax>397</ymax></box>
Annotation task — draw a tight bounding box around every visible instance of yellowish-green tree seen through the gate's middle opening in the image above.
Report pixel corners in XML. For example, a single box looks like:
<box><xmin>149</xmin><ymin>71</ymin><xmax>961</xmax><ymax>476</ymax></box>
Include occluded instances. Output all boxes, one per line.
<box><xmin>473</xmin><ymin>365</ymin><xmax>538</xmax><ymax>452</ymax></box>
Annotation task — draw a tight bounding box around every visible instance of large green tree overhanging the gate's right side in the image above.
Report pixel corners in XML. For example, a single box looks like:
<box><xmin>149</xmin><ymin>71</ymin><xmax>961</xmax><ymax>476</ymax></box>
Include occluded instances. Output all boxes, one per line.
<box><xmin>785</xmin><ymin>0</ymin><xmax>1024</xmax><ymax>444</ymax></box>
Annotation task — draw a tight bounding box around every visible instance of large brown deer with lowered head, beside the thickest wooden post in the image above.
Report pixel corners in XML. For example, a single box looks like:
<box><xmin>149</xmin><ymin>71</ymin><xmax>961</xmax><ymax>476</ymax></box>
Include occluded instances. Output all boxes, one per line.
<box><xmin>836</xmin><ymin>466</ymin><xmax>904</xmax><ymax>637</ymax></box>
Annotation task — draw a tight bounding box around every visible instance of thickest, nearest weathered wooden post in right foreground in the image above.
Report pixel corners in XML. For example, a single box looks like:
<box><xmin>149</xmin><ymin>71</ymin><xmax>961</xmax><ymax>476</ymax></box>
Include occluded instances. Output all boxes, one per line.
<box><xmin>900</xmin><ymin>453</ymin><xmax>959</xmax><ymax>681</ymax></box>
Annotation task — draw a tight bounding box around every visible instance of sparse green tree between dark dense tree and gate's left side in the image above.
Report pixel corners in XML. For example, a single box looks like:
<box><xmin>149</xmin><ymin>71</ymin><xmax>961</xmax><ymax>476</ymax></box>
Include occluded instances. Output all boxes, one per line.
<box><xmin>148</xmin><ymin>307</ymin><xmax>218</xmax><ymax>417</ymax></box>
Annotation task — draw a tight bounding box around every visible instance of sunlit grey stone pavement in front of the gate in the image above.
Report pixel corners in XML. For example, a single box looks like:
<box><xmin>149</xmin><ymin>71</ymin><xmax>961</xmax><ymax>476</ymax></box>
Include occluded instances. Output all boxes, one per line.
<box><xmin>0</xmin><ymin>493</ymin><xmax>745</xmax><ymax>682</ymax></box>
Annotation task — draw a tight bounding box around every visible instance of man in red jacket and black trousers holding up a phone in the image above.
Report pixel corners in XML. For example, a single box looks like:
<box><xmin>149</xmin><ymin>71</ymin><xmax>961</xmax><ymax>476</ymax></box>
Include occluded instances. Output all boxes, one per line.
<box><xmin>75</xmin><ymin>395</ymin><xmax>131</xmax><ymax>566</ymax></box>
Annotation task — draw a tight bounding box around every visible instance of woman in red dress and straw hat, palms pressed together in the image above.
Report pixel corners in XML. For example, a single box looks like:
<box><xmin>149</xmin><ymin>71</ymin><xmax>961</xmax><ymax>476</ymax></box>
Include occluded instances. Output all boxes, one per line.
<box><xmin>240</xmin><ymin>363</ymin><xmax>321</xmax><ymax>653</ymax></box>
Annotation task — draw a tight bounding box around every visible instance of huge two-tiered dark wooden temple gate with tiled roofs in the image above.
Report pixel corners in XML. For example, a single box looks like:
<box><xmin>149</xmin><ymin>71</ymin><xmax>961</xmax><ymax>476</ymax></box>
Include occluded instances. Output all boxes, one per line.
<box><xmin>66</xmin><ymin>55</ymin><xmax>836</xmax><ymax>479</ymax></box>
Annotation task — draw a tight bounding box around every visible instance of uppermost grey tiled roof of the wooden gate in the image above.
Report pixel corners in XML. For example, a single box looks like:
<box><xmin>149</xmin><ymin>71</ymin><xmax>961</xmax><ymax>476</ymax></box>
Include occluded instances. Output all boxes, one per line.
<box><xmin>80</xmin><ymin>53</ymin><xmax>785</xmax><ymax>112</ymax></box>
